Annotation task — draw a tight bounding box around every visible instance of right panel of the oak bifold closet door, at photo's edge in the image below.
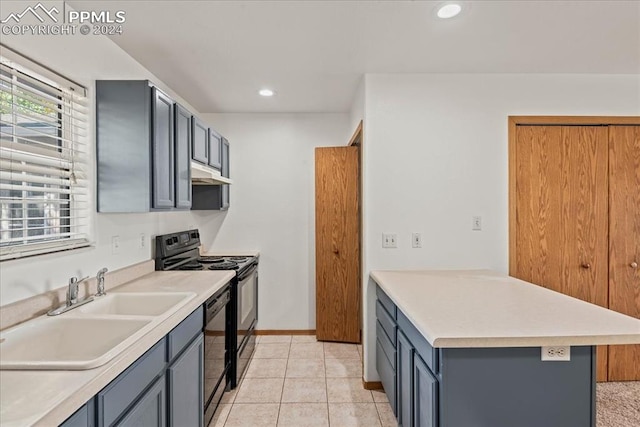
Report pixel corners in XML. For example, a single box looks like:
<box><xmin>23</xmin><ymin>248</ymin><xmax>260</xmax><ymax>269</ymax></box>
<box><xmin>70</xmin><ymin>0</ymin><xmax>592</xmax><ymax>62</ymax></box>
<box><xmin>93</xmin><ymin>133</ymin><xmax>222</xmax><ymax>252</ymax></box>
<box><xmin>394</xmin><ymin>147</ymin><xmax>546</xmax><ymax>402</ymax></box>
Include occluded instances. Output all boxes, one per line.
<box><xmin>609</xmin><ymin>126</ymin><xmax>640</xmax><ymax>381</ymax></box>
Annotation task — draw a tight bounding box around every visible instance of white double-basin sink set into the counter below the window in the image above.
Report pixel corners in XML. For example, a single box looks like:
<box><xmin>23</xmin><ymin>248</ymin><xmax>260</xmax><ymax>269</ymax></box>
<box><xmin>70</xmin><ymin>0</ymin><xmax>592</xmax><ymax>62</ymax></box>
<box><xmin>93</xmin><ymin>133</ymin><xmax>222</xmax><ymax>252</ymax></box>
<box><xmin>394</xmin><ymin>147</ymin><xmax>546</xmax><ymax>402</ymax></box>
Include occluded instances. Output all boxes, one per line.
<box><xmin>0</xmin><ymin>292</ymin><xmax>196</xmax><ymax>370</ymax></box>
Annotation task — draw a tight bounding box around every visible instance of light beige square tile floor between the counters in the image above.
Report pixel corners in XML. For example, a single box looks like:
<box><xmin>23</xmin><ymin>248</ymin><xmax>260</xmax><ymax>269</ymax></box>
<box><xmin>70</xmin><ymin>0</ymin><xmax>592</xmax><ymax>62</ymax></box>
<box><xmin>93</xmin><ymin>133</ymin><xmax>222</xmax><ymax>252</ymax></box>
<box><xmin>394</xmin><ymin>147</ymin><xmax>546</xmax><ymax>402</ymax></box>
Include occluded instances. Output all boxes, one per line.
<box><xmin>209</xmin><ymin>335</ymin><xmax>397</xmax><ymax>427</ymax></box>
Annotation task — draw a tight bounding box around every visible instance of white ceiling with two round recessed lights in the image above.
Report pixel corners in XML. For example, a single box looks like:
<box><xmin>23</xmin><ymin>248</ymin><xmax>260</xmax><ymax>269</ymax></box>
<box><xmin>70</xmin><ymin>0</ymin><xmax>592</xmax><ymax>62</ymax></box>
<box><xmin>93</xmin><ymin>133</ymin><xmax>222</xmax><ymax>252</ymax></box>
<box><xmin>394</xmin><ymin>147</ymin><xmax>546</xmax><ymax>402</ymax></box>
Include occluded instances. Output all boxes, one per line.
<box><xmin>68</xmin><ymin>0</ymin><xmax>640</xmax><ymax>113</ymax></box>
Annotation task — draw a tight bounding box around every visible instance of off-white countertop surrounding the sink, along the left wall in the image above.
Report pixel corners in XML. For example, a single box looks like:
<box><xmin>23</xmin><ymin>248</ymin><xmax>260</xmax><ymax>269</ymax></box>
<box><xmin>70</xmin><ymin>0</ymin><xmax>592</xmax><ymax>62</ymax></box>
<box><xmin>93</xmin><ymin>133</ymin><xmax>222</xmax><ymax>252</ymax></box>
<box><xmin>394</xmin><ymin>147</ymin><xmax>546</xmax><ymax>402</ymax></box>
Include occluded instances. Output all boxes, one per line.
<box><xmin>0</xmin><ymin>271</ymin><xmax>235</xmax><ymax>427</ymax></box>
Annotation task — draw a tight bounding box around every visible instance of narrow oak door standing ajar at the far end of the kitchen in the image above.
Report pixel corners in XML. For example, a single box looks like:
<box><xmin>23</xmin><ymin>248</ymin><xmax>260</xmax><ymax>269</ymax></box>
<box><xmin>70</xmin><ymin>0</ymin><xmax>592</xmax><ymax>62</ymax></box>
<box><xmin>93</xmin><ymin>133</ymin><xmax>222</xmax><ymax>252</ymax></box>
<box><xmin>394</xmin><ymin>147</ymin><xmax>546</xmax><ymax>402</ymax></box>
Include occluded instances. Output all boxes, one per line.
<box><xmin>315</xmin><ymin>146</ymin><xmax>361</xmax><ymax>343</ymax></box>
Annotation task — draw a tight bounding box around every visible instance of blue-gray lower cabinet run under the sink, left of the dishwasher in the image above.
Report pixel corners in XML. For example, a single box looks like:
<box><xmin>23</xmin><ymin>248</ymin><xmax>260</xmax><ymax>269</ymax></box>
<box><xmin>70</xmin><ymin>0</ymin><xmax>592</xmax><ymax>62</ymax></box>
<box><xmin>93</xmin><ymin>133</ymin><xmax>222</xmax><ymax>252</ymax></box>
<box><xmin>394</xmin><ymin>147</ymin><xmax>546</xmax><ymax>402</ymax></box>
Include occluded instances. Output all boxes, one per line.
<box><xmin>61</xmin><ymin>307</ymin><xmax>204</xmax><ymax>427</ymax></box>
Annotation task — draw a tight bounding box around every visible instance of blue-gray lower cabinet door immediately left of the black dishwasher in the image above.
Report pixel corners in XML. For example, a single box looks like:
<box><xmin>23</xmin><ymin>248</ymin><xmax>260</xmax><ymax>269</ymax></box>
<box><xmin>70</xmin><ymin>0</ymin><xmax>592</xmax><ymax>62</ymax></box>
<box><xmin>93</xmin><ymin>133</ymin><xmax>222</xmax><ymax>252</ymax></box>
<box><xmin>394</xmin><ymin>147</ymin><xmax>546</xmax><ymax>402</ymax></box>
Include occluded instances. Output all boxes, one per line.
<box><xmin>167</xmin><ymin>333</ymin><xmax>204</xmax><ymax>427</ymax></box>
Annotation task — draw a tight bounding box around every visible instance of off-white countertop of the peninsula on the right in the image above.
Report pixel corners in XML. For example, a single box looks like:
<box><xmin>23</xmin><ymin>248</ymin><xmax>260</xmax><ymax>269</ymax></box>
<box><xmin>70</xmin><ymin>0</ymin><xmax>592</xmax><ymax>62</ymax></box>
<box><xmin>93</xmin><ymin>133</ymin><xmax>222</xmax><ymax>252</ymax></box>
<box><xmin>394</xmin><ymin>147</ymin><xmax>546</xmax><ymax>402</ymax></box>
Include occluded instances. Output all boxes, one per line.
<box><xmin>371</xmin><ymin>270</ymin><xmax>640</xmax><ymax>348</ymax></box>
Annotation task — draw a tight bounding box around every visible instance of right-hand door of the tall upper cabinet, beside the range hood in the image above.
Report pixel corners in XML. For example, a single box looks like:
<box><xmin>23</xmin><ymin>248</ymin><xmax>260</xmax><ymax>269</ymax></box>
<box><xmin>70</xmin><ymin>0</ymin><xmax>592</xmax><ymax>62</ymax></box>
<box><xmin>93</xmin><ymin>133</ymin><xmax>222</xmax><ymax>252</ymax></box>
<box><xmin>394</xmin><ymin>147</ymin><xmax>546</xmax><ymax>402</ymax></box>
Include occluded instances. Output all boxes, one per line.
<box><xmin>175</xmin><ymin>104</ymin><xmax>193</xmax><ymax>209</ymax></box>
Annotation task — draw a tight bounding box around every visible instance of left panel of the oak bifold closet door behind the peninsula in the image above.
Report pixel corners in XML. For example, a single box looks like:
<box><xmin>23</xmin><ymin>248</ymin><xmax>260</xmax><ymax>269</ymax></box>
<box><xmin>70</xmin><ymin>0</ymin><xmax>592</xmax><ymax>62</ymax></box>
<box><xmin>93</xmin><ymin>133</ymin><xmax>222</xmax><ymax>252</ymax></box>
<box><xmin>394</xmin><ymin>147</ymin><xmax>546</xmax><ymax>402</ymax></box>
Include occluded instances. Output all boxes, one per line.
<box><xmin>510</xmin><ymin>126</ymin><xmax>608</xmax><ymax>381</ymax></box>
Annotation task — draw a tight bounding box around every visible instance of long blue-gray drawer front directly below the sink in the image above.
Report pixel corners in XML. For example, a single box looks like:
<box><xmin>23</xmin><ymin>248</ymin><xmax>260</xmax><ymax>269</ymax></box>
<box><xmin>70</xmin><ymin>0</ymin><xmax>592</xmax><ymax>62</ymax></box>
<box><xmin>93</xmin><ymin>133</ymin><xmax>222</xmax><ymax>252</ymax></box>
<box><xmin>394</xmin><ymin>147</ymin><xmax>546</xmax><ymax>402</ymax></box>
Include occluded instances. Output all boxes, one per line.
<box><xmin>97</xmin><ymin>338</ymin><xmax>167</xmax><ymax>427</ymax></box>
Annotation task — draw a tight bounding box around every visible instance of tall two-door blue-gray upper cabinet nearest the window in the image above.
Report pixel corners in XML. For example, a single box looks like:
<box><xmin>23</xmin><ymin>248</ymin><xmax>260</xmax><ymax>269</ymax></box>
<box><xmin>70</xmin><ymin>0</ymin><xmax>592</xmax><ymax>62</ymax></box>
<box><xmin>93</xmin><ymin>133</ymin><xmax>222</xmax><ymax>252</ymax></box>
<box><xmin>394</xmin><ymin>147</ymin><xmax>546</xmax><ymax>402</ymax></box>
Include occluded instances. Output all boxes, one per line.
<box><xmin>96</xmin><ymin>80</ymin><xmax>191</xmax><ymax>212</ymax></box>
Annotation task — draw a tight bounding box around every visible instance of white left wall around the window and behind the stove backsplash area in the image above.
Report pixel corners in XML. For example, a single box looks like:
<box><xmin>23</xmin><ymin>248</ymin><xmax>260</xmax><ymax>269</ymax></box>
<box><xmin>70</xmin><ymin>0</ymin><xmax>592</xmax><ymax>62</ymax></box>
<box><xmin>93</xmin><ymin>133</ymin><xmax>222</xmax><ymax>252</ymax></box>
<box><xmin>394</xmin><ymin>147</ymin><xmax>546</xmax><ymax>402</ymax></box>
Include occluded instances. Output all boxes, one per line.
<box><xmin>0</xmin><ymin>16</ymin><xmax>224</xmax><ymax>305</ymax></box>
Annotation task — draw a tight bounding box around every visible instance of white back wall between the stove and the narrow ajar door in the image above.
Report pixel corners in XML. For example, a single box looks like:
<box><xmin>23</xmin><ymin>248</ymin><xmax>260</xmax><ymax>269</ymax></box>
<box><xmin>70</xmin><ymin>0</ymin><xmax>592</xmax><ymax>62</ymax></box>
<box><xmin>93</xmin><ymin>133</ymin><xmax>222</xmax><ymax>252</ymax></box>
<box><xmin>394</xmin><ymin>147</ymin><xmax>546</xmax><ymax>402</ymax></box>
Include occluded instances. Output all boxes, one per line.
<box><xmin>203</xmin><ymin>114</ymin><xmax>349</xmax><ymax>329</ymax></box>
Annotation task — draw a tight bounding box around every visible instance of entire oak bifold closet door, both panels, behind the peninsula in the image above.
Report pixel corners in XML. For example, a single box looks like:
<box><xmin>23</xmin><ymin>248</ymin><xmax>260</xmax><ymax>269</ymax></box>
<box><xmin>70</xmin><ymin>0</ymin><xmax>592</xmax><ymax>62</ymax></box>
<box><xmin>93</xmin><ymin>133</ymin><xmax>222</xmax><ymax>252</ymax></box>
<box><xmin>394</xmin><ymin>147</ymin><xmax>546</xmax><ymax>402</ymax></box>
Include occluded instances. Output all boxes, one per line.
<box><xmin>510</xmin><ymin>119</ymin><xmax>640</xmax><ymax>381</ymax></box>
